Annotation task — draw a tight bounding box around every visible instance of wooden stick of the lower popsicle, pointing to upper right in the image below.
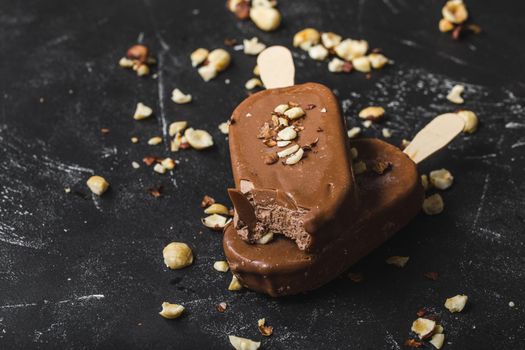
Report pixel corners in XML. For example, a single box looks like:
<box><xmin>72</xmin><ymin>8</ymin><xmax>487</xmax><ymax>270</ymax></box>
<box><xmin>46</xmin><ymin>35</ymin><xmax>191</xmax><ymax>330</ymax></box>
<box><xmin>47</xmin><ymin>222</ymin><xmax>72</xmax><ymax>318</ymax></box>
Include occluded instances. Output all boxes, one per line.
<box><xmin>403</xmin><ymin>113</ymin><xmax>465</xmax><ymax>164</ymax></box>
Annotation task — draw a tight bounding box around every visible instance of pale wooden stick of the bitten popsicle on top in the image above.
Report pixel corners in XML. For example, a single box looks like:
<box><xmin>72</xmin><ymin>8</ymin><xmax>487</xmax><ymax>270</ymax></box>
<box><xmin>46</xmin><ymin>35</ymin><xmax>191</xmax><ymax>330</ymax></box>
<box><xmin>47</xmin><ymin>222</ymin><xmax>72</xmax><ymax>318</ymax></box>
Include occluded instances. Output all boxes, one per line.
<box><xmin>257</xmin><ymin>46</ymin><xmax>295</xmax><ymax>89</ymax></box>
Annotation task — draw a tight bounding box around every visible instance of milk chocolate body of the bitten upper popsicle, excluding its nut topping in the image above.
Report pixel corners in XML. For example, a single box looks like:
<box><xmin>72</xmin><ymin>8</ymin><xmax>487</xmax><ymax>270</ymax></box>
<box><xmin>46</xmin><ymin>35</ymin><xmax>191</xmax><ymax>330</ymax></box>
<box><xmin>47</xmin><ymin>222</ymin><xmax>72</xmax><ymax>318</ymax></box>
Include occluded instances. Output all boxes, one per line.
<box><xmin>229</xmin><ymin>83</ymin><xmax>357</xmax><ymax>253</ymax></box>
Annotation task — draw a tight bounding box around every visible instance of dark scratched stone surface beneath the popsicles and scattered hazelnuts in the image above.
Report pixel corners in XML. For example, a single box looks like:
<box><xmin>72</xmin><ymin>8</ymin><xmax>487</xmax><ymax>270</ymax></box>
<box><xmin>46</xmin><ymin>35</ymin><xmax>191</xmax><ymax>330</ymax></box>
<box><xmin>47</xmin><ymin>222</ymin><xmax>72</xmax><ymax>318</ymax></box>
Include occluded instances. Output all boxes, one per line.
<box><xmin>0</xmin><ymin>0</ymin><xmax>525</xmax><ymax>349</ymax></box>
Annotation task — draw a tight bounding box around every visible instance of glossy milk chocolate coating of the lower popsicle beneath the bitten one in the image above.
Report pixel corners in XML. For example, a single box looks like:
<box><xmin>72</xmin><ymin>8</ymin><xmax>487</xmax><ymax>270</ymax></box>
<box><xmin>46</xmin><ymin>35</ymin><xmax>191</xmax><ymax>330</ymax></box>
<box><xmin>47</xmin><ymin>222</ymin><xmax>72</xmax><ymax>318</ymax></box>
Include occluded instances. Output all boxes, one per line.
<box><xmin>223</xmin><ymin>139</ymin><xmax>424</xmax><ymax>296</ymax></box>
